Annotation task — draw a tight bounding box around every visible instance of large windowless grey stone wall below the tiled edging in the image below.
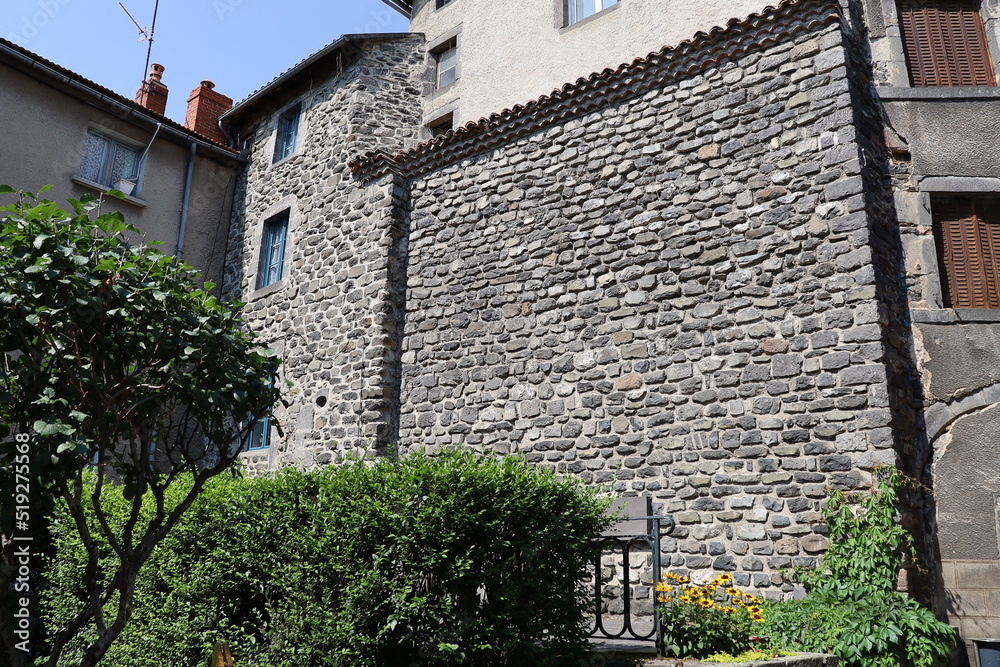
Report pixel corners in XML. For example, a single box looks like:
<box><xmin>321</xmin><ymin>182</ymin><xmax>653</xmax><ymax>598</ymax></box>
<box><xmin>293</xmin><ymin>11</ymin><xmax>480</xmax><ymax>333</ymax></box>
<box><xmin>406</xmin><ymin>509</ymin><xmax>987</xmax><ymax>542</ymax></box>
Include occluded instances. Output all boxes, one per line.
<box><xmin>386</xmin><ymin>1</ymin><xmax>893</xmax><ymax>596</ymax></box>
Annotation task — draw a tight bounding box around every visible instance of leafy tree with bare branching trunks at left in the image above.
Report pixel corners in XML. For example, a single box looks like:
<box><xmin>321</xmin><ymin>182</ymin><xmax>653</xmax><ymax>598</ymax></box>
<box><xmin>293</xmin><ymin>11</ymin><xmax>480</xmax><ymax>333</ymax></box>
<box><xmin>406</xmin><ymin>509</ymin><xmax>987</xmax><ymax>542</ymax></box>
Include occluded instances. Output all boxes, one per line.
<box><xmin>0</xmin><ymin>186</ymin><xmax>280</xmax><ymax>667</ymax></box>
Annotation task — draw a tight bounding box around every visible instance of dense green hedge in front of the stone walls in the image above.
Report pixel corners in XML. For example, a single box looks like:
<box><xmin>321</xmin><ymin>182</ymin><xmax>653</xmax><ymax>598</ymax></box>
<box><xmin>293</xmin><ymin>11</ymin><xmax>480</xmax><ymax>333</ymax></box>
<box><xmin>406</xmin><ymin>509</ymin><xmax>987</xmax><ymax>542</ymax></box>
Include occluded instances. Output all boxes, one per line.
<box><xmin>46</xmin><ymin>453</ymin><xmax>607</xmax><ymax>667</ymax></box>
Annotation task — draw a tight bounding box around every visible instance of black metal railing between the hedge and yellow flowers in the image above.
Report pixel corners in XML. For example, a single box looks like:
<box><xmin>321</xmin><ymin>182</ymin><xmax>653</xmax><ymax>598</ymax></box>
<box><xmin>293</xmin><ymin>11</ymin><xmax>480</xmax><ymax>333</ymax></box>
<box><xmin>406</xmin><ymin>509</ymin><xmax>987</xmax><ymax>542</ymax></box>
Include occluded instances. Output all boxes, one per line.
<box><xmin>591</xmin><ymin>516</ymin><xmax>675</xmax><ymax>656</ymax></box>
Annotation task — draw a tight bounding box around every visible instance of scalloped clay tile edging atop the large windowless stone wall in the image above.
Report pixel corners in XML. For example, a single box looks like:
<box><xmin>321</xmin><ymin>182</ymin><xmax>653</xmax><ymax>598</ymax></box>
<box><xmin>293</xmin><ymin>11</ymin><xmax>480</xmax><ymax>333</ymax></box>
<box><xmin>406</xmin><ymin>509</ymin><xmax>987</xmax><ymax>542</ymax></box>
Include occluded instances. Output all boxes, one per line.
<box><xmin>350</xmin><ymin>0</ymin><xmax>841</xmax><ymax>180</ymax></box>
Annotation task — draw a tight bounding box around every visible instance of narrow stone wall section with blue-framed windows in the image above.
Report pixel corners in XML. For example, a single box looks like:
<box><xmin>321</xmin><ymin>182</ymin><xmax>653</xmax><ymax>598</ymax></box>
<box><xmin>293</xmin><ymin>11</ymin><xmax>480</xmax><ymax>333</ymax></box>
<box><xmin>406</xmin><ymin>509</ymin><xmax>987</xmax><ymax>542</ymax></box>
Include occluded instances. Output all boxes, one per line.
<box><xmin>225</xmin><ymin>36</ymin><xmax>426</xmax><ymax>469</ymax></box>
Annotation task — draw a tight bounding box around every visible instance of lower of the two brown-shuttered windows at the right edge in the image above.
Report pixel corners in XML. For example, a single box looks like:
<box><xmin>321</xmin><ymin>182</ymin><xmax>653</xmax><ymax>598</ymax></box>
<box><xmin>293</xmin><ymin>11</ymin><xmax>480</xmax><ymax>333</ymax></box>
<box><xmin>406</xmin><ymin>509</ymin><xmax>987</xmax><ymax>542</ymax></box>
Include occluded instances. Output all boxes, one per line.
<box><xmin>931</xmin><ymin>196</ymin><xmax>1000</xmax><ymax>308</ymax></box>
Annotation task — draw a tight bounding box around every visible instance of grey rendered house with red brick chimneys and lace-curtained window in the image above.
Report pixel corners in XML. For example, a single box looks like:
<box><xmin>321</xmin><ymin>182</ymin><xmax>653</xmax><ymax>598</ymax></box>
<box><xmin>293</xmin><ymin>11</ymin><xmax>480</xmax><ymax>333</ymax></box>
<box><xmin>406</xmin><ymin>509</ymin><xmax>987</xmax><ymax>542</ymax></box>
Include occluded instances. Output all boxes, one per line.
<box><xmin>0</xmin><ymin>40</ymin><xmax>242</xmax><ymax>285</ymax></box>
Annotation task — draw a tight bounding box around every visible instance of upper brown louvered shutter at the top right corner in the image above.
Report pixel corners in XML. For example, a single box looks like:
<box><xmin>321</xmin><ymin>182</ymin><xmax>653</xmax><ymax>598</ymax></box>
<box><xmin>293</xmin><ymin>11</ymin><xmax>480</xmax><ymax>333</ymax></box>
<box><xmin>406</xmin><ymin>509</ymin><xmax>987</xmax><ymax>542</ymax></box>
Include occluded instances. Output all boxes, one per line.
<box><xmin>898</xmin><ymin>0</ymin><xmax>996</xmax><ymax>86</ymax></box>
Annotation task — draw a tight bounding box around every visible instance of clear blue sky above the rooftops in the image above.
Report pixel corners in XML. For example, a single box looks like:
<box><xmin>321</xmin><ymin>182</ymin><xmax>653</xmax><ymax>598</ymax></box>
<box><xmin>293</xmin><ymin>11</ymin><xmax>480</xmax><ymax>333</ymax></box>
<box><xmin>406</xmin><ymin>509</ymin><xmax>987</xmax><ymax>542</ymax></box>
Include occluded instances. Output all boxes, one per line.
<box><xmin>0</xmin><ymin>0</ymin><xmax>409</xmax><ymax>122</ymax></box>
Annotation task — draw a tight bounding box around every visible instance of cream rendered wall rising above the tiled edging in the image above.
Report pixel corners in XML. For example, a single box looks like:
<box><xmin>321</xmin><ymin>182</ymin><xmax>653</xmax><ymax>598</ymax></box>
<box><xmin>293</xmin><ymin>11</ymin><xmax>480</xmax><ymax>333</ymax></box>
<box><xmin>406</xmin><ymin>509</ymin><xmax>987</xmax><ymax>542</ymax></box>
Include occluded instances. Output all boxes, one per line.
<box><xmin>411</xmin><ymin>0</ymin><xmax>777</xmax><ymax>124</ymax></box>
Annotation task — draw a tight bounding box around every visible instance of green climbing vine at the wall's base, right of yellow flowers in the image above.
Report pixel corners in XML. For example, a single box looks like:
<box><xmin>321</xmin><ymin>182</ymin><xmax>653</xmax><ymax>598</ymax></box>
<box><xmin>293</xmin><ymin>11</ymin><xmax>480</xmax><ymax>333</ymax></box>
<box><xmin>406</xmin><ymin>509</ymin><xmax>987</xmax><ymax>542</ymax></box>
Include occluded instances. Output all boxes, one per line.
<box><xmin>766</xmin><ymin>468</ymin><xmax>955</xmax><ymax>667</ymax></box>
